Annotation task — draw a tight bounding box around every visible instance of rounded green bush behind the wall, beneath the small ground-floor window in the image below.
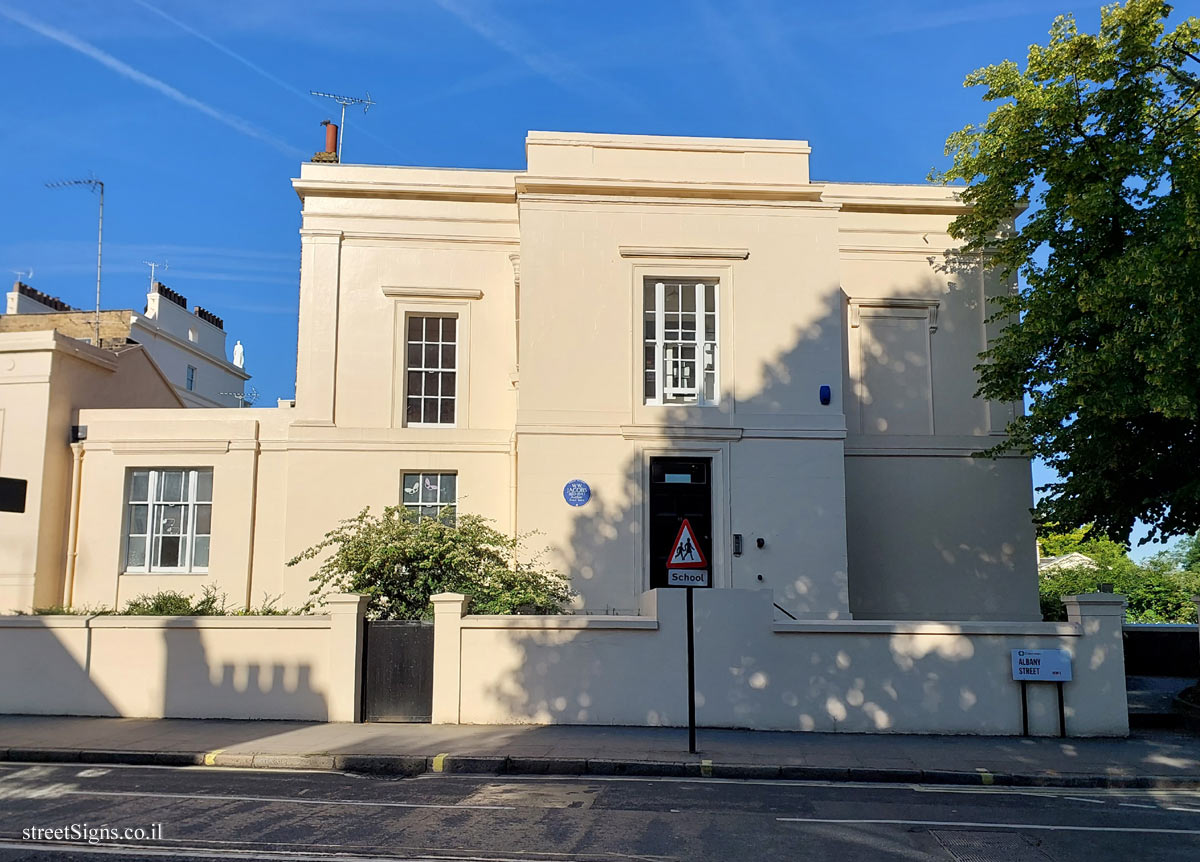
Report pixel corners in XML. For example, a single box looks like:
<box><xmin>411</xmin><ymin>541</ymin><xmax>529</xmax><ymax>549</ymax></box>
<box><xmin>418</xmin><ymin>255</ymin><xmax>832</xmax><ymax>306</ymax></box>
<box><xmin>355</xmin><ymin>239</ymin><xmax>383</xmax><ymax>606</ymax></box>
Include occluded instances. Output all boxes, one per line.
<box><xmin>288</xmin><ymin>505</ymin><xmax>571</xmax><ymax>619</ymax></box>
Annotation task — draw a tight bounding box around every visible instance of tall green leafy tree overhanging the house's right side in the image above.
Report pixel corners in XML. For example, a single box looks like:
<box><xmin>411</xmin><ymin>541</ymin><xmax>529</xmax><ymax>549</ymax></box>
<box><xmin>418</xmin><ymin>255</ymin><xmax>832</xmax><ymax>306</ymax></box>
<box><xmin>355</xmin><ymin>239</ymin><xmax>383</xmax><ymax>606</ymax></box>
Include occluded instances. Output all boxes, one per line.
<box><xmin>931</xmin><ymin>0</ymin><xmax>1200</xmax><ymax>544</ymax></box>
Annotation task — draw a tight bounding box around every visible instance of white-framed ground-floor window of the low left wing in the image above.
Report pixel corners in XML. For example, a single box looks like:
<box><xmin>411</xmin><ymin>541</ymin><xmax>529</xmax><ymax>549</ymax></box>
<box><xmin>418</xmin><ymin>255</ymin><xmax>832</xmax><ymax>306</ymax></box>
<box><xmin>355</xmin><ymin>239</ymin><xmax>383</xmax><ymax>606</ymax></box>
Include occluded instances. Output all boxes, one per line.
<box><xmin>121</xmin><ymin>466</ymin><xmax>215</xmax><ymax>575</ymax></box>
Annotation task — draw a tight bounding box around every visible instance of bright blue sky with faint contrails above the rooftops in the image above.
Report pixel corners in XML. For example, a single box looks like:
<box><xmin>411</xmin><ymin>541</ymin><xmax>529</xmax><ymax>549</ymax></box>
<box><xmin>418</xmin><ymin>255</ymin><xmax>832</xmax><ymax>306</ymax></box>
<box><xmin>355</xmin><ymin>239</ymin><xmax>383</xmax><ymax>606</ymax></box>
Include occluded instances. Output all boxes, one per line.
<box><xmin>0</xmin><ymin>0</ymin><xmax>1192</xmax><ymax>556</ymax></box>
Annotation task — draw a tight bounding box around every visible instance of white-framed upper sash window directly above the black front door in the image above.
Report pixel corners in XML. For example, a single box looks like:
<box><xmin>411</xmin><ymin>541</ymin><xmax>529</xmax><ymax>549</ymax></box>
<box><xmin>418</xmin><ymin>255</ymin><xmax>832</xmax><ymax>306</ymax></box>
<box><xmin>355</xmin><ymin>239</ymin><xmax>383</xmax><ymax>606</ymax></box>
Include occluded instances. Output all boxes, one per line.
<box><xmin>642</xmin><ymin>279</ymin><xmax>720</xmax><ymax>405</ymax></box>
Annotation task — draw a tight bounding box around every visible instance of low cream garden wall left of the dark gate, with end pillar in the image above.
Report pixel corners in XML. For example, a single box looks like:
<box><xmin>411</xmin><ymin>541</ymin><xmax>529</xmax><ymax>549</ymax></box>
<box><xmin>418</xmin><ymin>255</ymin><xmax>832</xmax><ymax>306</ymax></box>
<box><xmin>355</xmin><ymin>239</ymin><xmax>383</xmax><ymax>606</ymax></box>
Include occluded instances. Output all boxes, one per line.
<box><xmin>0</xmin><ymin>595</ymin><xmax>365</xmax><ymax>722</ymax></box>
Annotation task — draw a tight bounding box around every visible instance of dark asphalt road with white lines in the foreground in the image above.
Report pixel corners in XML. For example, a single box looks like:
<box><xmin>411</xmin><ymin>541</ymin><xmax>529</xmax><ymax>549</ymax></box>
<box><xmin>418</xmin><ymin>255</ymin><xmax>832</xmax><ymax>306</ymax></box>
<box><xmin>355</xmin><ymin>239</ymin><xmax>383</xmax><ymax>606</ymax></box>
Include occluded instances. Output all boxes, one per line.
<box><xmin>0</xmin><ymin>764</ymin><xmax>1200</xmax><ymax>862</ymax></box>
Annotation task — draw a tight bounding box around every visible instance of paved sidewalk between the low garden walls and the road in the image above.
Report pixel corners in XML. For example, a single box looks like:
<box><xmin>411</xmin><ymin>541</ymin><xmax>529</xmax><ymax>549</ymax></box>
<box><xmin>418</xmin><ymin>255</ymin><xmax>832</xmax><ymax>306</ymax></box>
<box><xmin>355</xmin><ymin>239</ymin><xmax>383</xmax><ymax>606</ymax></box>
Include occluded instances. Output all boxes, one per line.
<box><xmin>0</xmin><ymin>716</ymin><xmax>1200</xmax><ymax>789</ymax></box>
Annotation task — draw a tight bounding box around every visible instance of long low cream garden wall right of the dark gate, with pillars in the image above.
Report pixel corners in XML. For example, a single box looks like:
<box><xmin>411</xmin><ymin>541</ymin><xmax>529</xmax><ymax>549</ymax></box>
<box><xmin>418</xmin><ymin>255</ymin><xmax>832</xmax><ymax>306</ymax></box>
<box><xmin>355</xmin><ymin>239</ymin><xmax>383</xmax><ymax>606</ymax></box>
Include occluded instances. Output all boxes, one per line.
<box><xmin>433</xmin><ymin>589</ymin><xmax>1128</xmax><ymax>736</ymax></box>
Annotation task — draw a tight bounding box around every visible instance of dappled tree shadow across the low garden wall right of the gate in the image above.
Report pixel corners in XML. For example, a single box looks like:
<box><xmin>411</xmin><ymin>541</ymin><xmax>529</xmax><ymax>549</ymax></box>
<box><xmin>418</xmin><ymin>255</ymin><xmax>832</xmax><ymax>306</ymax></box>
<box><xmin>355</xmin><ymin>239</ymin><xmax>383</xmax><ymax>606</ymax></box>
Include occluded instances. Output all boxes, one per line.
<box><xmin>462</xmin><ymin>589</ymin><xmax>1104</xmax><ymax>735</ymax></box>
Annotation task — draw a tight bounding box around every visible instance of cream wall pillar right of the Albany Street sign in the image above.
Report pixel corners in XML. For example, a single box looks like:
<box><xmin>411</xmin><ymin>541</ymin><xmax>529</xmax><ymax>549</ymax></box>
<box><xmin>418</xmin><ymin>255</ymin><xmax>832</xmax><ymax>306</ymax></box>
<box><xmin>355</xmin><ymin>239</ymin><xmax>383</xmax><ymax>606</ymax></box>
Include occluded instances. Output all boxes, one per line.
<box><xmin>1062</xmin><ymin>593</ymin><xmax>1129</xmax><ymax>736</ymax></box>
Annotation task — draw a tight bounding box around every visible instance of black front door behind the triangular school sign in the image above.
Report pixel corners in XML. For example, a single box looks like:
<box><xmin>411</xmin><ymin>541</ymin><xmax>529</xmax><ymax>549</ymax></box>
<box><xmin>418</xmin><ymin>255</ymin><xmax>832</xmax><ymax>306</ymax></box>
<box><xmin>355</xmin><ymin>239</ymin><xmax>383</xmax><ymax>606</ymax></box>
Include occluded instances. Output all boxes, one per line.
<box><xmin>649</xmin><ymin>457</ymin><xmax>713</xmax><ymax>589</ymax></box>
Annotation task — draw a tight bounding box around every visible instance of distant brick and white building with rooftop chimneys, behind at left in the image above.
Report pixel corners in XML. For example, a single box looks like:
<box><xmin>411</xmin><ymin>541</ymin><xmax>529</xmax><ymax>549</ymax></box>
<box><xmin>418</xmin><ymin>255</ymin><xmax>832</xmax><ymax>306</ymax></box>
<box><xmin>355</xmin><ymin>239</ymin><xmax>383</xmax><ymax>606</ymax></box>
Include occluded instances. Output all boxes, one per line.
<box><xmin>0</xmin><ymin>281</ymin><xmax>250</xmax><ymax>407</ymax></box>
